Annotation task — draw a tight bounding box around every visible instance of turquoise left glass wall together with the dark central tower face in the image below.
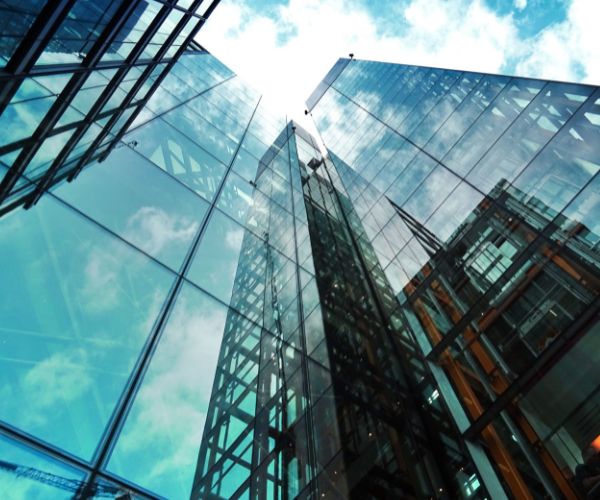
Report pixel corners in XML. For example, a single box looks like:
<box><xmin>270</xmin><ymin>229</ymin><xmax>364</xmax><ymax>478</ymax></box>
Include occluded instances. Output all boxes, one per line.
<box><xmin>0</xmin><ymin>46</ymin><xmax>494</xmax><ymax>499</ymax></box>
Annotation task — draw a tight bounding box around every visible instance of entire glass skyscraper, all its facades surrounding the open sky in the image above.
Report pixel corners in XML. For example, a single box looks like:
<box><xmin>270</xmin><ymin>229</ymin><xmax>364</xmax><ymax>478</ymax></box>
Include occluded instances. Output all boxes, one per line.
<box><xmin>0</xmin><ymin>0</ymin><xmax>600</xmax><ymax>499</ymax></box>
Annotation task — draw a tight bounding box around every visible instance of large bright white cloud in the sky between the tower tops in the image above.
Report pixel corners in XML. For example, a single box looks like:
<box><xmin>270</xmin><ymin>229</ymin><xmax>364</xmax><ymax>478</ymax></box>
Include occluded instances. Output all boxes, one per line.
<box><xmin>199</xmin><ymin>0</ymin><xmax>518</xmax><ymax>132</ymax></box>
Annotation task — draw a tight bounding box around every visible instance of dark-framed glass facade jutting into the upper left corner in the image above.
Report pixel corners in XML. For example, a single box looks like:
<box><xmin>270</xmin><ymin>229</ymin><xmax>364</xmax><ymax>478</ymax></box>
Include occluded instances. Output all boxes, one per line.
<box><xmin>0</xmin><ymin>0</ymin><xmax>218</xmax><ymax>215</ymax></box>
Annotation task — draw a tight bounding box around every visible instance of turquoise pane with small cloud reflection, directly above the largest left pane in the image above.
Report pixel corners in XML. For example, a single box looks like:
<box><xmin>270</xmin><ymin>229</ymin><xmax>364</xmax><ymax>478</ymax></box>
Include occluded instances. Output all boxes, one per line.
<box><xmin>54</xmin><ymin>148</ymin><xmax>208</xmax><ymax>269</ymax></box>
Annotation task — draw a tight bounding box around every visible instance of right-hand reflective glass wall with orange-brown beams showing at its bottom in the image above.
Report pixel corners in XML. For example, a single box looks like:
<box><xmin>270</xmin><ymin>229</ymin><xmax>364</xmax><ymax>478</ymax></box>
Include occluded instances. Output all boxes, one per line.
<box><xmin>308</xmin><ymin>59</ymin><xmax>600</xmax><ymax>498</ymax></box>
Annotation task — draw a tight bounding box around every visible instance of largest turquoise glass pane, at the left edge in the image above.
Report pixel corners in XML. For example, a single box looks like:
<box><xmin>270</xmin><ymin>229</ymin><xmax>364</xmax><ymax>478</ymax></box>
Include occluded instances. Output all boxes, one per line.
<box><xmin>0</xmin><ymin>196</ymin><xmax>175</xmax><ymax>460</ymax></box>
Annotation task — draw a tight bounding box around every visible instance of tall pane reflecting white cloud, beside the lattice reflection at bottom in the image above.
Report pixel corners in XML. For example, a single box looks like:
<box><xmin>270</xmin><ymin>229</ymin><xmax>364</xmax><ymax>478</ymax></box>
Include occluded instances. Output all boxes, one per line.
<box><xmin>108</xmin><ymin>284</ymin><xmax>232</xmax><ymax>498</ymax></box>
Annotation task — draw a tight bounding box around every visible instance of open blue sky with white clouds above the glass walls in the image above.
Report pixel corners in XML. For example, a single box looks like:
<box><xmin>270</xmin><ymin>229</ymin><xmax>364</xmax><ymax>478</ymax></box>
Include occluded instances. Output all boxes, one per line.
<box><xmin>198</xmin><ymin>0</ymin><xmax>600</xmax><ymax>125</ymax></box>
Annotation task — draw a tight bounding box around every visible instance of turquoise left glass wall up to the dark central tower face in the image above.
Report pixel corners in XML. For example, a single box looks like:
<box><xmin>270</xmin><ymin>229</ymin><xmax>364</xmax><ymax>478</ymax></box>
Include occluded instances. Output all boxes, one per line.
<box><xmin>0</xmin><ymin>54</ymin><xmax>339</xmax><ymax>498</ymax></box>
